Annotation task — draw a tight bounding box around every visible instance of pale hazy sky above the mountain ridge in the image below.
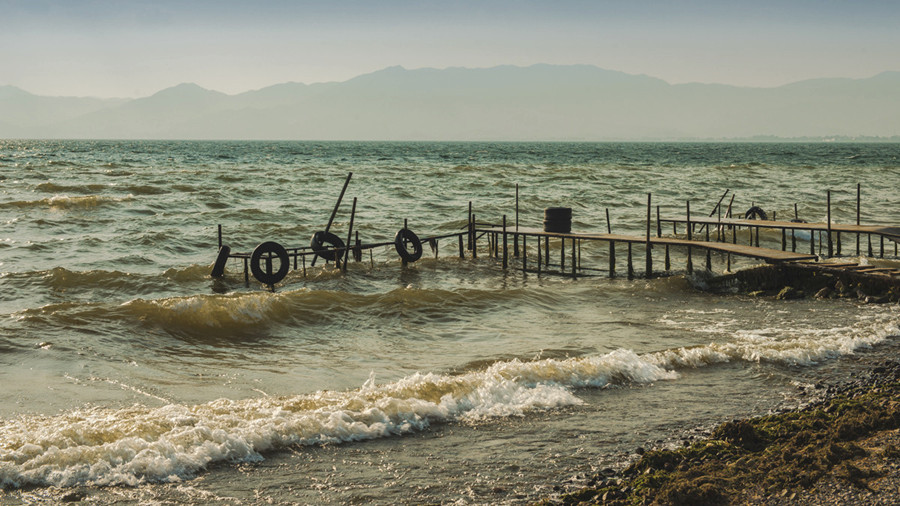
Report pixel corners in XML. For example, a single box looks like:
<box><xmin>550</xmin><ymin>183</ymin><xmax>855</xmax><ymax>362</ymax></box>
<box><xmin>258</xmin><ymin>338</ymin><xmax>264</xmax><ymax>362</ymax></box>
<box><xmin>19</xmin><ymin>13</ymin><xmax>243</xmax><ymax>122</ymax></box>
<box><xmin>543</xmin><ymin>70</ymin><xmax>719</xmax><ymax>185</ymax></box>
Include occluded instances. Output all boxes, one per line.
<box><xmin>0</xmin><ymin>0</ymin><xmax>900</xmax><ymax>97</ymax></box>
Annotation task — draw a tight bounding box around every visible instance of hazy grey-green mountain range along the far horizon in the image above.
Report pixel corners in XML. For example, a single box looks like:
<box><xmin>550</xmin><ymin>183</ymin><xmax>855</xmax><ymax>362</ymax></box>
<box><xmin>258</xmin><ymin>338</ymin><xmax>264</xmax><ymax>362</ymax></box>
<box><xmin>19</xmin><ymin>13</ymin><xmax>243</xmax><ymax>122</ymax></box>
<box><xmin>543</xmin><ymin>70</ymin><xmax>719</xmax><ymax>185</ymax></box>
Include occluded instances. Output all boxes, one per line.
<box><xmin>0</xmin><ymin>65</ymin><xmax>900</xmax><ymax>141</ymax></box>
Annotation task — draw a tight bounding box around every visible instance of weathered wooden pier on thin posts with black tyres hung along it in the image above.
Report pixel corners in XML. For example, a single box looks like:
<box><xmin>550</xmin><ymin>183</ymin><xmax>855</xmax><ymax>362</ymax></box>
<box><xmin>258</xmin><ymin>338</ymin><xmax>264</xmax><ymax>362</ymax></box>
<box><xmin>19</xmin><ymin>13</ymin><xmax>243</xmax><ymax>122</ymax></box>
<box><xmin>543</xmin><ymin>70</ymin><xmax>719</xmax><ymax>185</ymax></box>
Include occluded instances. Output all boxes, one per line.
<box><xmin>212</xmin><ymin>177</ymin><xmax>900</xmax><ymax>289</ymax></box>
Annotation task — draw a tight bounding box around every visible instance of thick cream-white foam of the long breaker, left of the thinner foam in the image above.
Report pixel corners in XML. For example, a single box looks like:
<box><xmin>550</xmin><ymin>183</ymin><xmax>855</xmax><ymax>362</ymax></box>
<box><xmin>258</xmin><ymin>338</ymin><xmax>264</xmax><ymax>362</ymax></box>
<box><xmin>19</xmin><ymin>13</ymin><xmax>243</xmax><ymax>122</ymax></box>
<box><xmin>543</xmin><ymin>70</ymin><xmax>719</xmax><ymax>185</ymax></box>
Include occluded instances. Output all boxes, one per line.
<box><xmin>0</xmin><ymin>350</ymin><xmax>677</xmax><ymax>487</ymax></box>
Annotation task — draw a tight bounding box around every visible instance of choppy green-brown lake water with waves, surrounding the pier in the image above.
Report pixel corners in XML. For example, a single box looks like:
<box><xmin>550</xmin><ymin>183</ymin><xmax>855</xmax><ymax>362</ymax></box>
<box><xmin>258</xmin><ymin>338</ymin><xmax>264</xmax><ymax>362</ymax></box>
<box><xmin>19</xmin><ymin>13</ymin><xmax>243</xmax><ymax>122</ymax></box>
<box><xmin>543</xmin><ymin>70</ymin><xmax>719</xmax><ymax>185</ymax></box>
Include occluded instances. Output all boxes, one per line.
<box><xmin>0</xmin><ymin>141</ymin><xmax>900</xmax><ymax>504</ymax></box>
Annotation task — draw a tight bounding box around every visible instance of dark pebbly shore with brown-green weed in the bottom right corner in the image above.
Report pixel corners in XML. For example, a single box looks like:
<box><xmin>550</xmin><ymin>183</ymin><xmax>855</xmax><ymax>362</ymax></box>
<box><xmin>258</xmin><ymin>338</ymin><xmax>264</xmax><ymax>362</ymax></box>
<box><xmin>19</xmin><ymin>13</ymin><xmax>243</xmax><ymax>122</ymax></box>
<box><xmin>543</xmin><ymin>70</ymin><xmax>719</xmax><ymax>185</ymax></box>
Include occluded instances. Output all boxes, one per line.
<box><xmin>539</xmin><ymin>354</ymin><xmax>900</xmax><ymax>505</ymax></box>
